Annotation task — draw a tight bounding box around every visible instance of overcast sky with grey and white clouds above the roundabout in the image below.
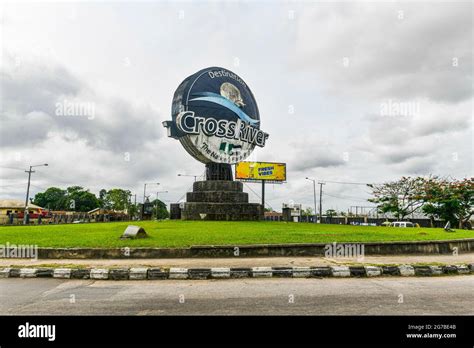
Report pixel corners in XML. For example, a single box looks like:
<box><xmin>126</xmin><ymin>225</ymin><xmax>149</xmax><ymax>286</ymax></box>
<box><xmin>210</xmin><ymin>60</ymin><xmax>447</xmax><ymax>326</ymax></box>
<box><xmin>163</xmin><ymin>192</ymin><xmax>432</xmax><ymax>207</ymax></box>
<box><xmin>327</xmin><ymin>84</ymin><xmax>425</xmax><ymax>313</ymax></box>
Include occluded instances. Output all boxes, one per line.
<box><xmin>0</xmin><ymin>1</ymin><xmax>473</xmax><ymax>210</ymax></box>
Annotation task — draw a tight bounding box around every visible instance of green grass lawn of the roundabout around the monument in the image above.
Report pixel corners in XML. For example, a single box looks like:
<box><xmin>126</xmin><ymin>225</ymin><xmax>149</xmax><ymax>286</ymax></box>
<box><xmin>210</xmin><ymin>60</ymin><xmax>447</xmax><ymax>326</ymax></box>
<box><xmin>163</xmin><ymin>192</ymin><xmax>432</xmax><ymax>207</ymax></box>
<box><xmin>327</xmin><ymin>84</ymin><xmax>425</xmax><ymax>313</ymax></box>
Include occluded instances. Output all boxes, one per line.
<box><xmin>0</xmin><ymin>220</ymin><xmax>474</xmax><ymax>248</ymax></box>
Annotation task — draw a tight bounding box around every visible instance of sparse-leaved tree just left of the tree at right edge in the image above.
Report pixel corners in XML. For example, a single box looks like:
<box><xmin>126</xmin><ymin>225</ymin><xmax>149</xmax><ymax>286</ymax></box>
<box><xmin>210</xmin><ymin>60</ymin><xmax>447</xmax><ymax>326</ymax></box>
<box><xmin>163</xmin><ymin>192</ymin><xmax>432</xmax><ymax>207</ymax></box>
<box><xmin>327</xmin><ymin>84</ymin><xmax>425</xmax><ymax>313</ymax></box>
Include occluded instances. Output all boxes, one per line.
<box><xmin>367</xmin><ymin>176</ymin><xmax>425</xmax><ymax>220</ymax></box>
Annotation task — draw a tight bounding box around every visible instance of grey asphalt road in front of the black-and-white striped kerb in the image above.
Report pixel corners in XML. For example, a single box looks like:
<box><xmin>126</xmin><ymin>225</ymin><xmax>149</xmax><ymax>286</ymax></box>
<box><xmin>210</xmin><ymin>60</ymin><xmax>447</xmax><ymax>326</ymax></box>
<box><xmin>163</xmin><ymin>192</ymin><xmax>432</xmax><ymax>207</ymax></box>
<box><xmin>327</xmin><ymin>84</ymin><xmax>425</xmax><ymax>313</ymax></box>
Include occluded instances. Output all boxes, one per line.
<box><xmin>0</xmin><ymin>275</ymin><xmax>474</xmax><ymax>315</ymax></box>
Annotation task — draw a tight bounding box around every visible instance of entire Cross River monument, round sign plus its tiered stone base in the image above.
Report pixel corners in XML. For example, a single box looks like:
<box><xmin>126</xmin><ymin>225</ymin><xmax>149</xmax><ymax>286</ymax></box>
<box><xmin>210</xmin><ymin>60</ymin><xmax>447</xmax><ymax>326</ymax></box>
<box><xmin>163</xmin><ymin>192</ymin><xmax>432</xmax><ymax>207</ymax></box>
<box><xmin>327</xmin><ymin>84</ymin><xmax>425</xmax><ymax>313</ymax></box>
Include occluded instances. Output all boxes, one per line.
<box><xmin>163</xmin><ymin>67</ymin><xmax>268</xmax><ymax>220</ymax></box>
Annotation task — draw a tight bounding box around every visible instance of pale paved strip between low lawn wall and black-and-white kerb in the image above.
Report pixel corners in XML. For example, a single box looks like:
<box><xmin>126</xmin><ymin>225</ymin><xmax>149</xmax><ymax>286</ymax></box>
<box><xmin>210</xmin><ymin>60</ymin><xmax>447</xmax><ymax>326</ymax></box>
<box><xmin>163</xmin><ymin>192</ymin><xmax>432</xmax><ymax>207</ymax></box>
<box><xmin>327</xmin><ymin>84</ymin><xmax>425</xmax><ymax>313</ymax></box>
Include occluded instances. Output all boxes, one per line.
<box><xmin>0</xmin><ymin>253</ymin><xmax>474</xmax><ymax>268</ymax></box>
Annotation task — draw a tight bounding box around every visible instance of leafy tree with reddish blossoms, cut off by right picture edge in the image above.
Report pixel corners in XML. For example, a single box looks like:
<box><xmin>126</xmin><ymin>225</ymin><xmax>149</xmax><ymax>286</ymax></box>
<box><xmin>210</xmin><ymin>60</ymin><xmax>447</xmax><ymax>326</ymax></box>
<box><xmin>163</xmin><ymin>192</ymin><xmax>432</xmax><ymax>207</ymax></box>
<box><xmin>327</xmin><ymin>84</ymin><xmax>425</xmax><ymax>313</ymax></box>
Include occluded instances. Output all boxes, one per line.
<box><xmin>423</xmin><ymin>177</ymin><xmax>474</xmax><ymax>229</ymax></box>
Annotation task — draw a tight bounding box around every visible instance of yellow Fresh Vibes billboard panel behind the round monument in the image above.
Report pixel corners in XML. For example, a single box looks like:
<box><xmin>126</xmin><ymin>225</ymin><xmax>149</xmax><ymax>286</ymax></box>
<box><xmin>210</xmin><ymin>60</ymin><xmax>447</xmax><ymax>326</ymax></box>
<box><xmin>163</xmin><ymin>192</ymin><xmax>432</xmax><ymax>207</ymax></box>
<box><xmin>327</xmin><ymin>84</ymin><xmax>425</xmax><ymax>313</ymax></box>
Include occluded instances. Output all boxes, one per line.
<box><xmin>235</xmin><ymin>162</ymin><xmax>286</xmax><ymax>181</ymax></box>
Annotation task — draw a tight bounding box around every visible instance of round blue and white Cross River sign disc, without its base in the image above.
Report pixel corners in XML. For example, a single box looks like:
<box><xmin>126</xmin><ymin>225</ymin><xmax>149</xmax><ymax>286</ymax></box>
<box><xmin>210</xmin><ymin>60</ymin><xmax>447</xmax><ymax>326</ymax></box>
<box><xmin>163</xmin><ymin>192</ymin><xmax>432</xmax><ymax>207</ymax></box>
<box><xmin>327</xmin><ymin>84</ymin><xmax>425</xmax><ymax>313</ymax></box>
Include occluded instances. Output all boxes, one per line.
<box><xmin>163</xmin><ymin>67</ymin><xmax>268</xmax><ymax>164</ymax></box>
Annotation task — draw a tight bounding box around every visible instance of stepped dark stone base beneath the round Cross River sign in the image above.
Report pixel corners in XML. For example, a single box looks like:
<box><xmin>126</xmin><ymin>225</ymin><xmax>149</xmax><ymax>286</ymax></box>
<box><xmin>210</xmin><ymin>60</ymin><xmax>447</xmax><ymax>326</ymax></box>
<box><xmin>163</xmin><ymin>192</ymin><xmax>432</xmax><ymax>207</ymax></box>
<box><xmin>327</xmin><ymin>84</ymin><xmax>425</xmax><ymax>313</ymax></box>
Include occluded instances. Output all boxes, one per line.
<box><xmin>180</xmin><ymin>180</ymin><xmax>263</xmax><ymax>221</ymax></box>
